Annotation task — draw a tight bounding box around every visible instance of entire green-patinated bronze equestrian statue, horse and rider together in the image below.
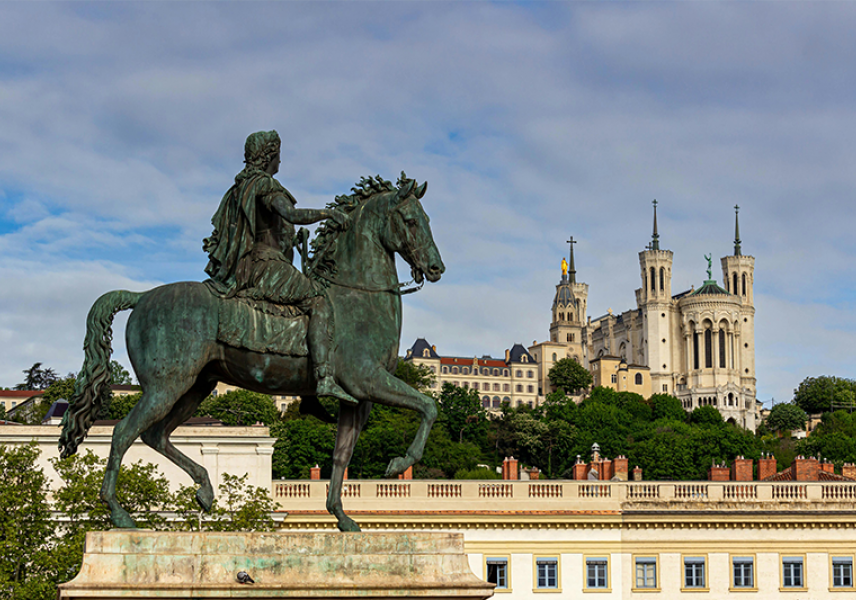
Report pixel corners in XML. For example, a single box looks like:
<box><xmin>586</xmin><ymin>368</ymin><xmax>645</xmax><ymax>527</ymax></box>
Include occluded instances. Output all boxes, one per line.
<box><xmin>60</xmin><ymin>132</ymin><xmax>445</xmax><ymax>531</ymax></box>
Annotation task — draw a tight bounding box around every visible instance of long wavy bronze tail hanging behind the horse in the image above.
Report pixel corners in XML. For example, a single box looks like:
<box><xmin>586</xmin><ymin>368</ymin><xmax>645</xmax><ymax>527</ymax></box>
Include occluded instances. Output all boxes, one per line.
<box><xmin>59</xmin><ymin>290</ymin><xmax>145</xmax><ymax>458</ymax></box>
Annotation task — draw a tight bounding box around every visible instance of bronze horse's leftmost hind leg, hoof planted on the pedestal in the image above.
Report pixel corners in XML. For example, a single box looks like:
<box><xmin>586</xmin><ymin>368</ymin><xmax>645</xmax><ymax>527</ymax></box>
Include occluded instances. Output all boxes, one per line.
<box><xmin>101</xmin><ymin>379</ymin><xmax>193</xmax><ymax>528</ymax></box>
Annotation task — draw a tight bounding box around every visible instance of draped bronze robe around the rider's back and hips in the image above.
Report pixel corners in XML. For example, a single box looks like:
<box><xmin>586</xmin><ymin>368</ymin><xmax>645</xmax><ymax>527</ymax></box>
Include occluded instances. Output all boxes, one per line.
<box><xmin>205</xmin><ymin>169</ymin><xmax>324</xmax><ymax>306</ymax></box>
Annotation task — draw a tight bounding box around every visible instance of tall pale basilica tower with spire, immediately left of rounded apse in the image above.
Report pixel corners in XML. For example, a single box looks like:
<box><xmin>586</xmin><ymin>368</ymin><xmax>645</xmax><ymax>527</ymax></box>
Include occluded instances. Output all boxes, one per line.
<box><xmin>636</xmin><ymin>200</ymin><xmax>676</xmax><ymax>393</ymax></box>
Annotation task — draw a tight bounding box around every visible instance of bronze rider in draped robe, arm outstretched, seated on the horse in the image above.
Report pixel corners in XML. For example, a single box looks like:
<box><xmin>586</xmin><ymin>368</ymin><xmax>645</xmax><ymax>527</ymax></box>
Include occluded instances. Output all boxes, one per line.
<box><xmin>204</xmin><ymin>131</ymin><xmax>357</xmax><ymax>404</ymax></box>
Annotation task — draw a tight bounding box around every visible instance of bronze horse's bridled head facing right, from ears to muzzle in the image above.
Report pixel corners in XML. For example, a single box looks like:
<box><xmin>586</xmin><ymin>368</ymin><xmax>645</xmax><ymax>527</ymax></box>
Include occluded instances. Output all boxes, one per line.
<box><xmin>383</xmin><ymin>173</ymin><xmax>446</xmax><ymax>283</ymax></box>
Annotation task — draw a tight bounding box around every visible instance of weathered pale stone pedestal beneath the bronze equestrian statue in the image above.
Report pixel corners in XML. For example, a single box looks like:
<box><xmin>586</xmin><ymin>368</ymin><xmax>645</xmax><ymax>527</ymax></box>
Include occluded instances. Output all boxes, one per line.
<box><xmin>59</xmin><ymin>530</ymin><xmax>494</xmax><ymax>600</ymax></box>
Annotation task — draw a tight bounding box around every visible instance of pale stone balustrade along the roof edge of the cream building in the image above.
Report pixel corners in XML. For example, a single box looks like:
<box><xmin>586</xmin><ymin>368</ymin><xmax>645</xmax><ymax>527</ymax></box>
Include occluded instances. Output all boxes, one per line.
<box><xmin>271</xmin><ymin>479</ymin><xmax>856</xmax><ymax>512</ymax></box>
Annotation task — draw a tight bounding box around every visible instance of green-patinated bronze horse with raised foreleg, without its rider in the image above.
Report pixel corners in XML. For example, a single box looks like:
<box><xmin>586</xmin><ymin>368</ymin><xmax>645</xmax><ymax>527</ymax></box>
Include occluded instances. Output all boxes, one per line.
<box><xmin>59</xmin><ymin>173</ymin><xmax>445</xmax><ymax>531</ymax></box>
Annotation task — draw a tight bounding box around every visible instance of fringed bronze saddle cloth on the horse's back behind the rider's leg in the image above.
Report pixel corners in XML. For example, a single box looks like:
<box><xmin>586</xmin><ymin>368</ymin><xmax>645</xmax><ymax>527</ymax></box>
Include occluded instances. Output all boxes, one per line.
<box><xmin>217</xmin><ymin>297</ymin><xmax>309</xmax><ymax>357</ymax></box>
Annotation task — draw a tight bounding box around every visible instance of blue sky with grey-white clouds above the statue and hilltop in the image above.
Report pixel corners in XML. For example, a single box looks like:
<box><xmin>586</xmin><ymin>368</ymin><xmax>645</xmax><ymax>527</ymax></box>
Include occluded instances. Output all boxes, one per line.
<box><xmin>0</xmin><ymin>2</ymin><xmax>856</xmax><ymax>401</ymax></box>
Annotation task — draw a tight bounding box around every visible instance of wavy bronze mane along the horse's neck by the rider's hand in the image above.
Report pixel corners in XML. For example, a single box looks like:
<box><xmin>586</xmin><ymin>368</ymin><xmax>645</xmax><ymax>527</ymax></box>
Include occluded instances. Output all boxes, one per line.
<box><xmin>308</xmin><ymin>171</ymin><xmax>409</xmax><ymax>286</ymax></box>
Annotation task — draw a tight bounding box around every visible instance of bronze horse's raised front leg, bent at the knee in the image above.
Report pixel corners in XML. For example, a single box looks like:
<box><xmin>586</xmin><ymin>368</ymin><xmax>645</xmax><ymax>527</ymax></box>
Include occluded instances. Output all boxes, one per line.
<box><xmin>358</xmin><ymin>368</ymin><xmax>437</xmax><ymax>477</ymax></box>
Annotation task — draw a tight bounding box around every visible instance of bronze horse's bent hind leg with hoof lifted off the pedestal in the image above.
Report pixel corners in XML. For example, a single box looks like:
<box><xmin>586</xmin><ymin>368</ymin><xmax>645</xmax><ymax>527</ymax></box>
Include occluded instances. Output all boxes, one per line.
<box><xmin>140</xmin><ymin>381</ymin><xmax>216</xmax><ymax>512</ymax></box>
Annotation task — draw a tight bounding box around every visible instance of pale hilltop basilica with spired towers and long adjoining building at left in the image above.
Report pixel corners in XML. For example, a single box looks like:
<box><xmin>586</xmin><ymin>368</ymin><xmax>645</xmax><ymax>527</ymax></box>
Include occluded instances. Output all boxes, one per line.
<box><xmin>405</xmin><ymin>201</ymin><xmax>760</xmax><ymax>430</ymax></box>
